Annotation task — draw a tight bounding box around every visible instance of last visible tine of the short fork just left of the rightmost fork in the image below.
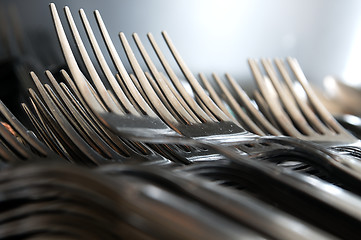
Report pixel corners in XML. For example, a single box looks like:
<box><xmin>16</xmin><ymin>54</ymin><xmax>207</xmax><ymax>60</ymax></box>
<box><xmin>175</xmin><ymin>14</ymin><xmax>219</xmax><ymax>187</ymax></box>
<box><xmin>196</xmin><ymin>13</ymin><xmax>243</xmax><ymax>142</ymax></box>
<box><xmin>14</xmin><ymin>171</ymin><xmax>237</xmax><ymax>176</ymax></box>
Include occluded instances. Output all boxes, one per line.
<box><xmin>226</xmin><ymin>74</ymin><xmax>281</xmax><ymax>136</ymax></box>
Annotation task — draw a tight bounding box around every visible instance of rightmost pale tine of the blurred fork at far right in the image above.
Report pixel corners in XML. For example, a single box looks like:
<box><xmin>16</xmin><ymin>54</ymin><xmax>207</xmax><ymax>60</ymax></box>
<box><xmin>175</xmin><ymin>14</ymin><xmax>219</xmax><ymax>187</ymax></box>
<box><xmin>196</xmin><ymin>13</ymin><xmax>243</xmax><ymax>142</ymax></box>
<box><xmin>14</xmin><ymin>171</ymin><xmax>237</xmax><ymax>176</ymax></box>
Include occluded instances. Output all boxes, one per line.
<box><xmin>287</xmin><ymin>58</ymin><xmax>347</xmax><ymax>134</ymax></box>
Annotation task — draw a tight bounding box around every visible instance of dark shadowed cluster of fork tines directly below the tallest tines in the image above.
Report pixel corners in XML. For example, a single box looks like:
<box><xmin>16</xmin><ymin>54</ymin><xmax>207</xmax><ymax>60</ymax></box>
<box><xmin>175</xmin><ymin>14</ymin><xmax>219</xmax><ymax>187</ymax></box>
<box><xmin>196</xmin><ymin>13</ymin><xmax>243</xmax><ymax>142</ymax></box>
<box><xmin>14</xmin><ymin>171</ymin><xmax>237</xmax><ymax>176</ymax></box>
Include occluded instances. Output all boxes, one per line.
<box><xmin>23</xmin><ymin>71</ymin><xmax>176</xmax><ymax>165</ymax></box>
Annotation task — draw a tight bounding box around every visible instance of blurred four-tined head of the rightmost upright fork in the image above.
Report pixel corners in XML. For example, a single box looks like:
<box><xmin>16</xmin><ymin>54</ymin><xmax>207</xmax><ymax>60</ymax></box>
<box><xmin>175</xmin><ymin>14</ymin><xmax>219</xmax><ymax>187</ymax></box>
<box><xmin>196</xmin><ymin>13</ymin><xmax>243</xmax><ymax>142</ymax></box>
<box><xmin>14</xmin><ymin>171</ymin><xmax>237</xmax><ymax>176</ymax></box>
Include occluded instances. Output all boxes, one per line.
<box><xmin>249</xmin><ymin>58</ymin><xmax>361</xmax><ymax>158</ymax></box>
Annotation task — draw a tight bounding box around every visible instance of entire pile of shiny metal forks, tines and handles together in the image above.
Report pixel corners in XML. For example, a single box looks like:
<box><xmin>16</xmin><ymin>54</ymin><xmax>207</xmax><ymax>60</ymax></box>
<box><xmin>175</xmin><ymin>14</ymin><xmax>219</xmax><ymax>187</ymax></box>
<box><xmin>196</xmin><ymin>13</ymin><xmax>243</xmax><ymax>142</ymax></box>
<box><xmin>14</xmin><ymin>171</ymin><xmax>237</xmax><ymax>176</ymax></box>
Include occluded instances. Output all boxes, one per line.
<box><xmin>0</xmin><ymin>3</ymin><xmax>361</xmax><ymax>239</ymax></box>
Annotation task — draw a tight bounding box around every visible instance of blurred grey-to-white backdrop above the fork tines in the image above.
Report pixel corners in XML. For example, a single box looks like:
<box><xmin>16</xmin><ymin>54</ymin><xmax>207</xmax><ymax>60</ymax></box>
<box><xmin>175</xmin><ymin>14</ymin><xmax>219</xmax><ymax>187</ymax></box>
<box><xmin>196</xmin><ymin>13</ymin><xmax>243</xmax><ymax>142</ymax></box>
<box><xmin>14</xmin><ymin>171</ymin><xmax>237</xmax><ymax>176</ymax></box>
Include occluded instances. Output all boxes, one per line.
<box><xmin>0</xmin><ymin>0</ymin><xmax>361</xmax><ymax>88</ymax></box>
